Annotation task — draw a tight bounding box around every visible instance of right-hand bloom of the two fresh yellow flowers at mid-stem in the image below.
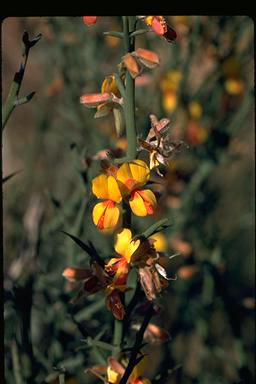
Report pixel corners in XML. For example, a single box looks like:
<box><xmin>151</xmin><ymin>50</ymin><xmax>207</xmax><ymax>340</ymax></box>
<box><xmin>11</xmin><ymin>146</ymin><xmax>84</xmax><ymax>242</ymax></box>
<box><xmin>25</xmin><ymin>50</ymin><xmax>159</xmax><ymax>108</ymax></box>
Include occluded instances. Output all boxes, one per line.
<box><xmin>116</xmin><ymin>160</ymin><xmax>157</xmax><ymax>216</ymax></box>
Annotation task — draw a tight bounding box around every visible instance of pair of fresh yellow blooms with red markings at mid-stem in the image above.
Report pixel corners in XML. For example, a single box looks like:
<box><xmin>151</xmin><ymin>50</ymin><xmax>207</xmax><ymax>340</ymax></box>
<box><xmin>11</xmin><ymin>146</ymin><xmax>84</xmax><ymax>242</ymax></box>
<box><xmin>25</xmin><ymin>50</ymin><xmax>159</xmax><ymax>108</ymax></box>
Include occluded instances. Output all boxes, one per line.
<box><xmin>92</xmin><ymin>159</ymin><xmax>157</xmax><ymax>230</ymax></box>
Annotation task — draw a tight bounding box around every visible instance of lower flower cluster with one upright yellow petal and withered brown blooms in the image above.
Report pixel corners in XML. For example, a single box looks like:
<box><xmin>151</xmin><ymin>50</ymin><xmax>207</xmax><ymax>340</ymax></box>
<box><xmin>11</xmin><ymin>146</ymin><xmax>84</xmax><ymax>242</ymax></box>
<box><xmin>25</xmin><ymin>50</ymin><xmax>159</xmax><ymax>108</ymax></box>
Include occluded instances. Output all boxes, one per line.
<box><xmin>63</xmin><ymin>228</ymin><xmax>170</xmax><ymax>320</ymax></box>
